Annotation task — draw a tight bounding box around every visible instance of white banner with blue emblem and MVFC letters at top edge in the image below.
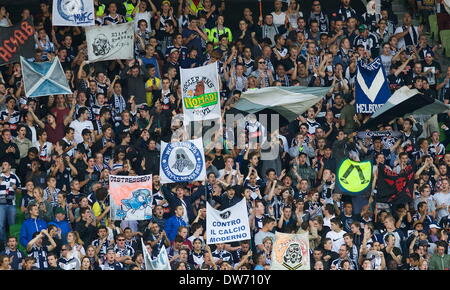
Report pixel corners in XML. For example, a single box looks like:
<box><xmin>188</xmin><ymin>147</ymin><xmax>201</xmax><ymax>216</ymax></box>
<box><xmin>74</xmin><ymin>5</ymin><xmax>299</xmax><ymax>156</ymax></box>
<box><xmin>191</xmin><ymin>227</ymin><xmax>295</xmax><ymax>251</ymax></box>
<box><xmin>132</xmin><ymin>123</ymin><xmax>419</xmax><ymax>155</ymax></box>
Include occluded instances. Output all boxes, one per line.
<box><xmin>52</xmin><ymin>0</ymin><xmax>95</xmax><ymax>26</ymax></box>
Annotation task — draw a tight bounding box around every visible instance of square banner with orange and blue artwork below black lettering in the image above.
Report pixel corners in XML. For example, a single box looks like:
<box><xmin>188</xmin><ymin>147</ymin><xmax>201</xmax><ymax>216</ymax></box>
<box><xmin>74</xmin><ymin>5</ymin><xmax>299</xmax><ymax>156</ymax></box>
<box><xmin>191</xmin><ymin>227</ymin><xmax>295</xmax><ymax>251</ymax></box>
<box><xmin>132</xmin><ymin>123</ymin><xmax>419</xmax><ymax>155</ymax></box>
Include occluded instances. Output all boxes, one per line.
<box><xmin>109</xmin><ymin>175</ymin><xmax>153</xmax><ymax>220</ymax></box>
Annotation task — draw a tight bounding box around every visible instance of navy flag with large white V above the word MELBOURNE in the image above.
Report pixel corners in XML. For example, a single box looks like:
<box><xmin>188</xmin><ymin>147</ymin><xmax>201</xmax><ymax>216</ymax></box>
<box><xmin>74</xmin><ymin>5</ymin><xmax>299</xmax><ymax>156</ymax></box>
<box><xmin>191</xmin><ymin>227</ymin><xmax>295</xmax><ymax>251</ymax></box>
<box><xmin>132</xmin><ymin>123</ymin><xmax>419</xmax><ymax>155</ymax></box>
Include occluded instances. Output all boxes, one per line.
<box><xmin>356</xmin><ymin>57</ymin><xmax>391</xmax><ymax>113</ymax></box>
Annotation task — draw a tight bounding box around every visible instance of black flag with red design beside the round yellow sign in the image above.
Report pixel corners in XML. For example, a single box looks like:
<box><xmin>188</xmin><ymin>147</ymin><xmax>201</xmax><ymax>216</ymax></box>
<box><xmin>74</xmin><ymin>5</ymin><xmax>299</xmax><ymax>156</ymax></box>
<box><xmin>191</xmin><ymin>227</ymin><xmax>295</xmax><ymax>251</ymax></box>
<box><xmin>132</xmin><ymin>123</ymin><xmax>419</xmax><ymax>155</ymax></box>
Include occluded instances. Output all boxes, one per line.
<box><xmin>375</xmin><ymin>164</ymin><xmax>415</xmax><ymax>204</ymax></box>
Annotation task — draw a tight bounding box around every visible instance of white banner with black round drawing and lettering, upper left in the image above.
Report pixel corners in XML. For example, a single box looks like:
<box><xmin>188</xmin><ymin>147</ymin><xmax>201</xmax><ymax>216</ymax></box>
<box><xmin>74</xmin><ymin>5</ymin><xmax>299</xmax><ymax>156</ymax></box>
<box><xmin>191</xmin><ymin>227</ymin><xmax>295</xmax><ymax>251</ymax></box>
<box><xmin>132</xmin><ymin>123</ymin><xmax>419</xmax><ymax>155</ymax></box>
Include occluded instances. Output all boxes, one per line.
<box><xmin>86</xmin><ymin>22</ymin><xmax>134</xmax><ymax>62</ymax></box>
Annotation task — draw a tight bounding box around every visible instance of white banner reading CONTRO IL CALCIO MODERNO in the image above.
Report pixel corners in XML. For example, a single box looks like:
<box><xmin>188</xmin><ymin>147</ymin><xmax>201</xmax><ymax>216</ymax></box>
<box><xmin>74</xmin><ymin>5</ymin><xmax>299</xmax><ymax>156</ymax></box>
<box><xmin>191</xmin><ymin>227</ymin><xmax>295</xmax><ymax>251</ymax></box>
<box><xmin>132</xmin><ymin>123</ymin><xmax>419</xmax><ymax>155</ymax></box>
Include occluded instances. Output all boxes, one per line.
<box><xmin>206</xmin><ymin>198</ymin><xmax>251</xmax><ymax>245</ymax></box>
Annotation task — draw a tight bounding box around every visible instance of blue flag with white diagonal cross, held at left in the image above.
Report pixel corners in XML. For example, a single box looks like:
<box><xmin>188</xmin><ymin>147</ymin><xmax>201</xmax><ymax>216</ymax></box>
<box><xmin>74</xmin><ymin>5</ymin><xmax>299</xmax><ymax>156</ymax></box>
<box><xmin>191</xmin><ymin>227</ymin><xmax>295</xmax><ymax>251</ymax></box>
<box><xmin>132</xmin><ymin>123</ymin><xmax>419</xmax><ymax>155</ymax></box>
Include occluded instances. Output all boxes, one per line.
<box><xmin>20</xmin><ymin>57</ymin><xmax>72</xmax><ymax>97</ymax></box>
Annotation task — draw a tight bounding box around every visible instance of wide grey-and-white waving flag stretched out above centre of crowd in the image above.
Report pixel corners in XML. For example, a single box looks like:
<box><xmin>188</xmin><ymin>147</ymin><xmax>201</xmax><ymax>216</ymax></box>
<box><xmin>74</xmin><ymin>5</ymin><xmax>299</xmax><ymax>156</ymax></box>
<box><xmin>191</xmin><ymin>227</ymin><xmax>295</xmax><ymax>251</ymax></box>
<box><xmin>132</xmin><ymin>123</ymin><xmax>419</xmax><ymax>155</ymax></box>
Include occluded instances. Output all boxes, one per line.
<box><xmin>235</xmin><ymin>87</ymin><xmax>330</xmax><ymax>121</ymax></box>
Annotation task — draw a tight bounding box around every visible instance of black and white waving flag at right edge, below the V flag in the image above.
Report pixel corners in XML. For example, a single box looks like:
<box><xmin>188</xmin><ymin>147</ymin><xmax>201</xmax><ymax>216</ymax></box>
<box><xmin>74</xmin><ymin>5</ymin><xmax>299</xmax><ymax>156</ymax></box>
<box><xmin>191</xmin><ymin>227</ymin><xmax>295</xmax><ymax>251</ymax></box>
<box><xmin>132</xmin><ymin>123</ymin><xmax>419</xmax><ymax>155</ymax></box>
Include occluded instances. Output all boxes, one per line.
<box><xmin>362</xmin><ymin>86</ymin><xmax>450</xmax><ymax>130</ymax></box>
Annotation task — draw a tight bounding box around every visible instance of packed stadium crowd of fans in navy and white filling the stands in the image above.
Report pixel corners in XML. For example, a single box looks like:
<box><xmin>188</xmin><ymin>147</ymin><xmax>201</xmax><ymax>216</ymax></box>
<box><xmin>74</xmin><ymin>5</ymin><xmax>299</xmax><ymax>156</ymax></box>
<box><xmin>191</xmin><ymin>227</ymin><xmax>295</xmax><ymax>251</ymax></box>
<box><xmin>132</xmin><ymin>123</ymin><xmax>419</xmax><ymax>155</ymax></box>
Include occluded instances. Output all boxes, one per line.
<box><xmin>0</xmin><ymin>0</ymin><xmax>450</xmax><ymax>270</ymax></box>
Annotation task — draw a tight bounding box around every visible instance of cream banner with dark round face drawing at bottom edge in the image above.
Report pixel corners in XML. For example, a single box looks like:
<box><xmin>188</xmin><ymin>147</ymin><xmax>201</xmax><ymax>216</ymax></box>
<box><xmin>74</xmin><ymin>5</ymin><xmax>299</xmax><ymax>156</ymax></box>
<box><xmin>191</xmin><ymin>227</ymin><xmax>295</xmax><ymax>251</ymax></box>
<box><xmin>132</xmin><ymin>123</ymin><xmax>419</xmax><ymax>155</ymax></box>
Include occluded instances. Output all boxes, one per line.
<box><xmin>270</xmin><ymin>232</ymin><xmax>310</xmax><ymax>270</ymax></box>
